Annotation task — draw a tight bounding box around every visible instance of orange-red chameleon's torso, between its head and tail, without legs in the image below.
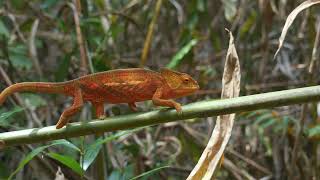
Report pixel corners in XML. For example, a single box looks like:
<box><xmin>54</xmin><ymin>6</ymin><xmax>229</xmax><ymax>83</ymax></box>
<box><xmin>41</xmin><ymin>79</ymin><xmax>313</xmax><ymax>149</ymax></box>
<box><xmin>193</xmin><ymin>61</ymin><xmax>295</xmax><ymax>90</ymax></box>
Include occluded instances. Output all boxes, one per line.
<box><xmin>77</xmin><ymin>68</ymin><xmax>162</xmax><ymax>104</ymax></box>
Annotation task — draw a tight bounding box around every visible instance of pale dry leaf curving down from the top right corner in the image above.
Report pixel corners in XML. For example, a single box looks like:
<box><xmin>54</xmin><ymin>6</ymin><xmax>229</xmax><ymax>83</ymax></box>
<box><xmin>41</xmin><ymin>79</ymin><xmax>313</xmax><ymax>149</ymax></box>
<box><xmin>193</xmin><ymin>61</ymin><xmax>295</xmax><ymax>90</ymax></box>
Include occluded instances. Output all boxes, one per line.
<box><xmin>274</xmin><ymin>0</ymin><xmax>320</xmax><ymax>59</ymax></box>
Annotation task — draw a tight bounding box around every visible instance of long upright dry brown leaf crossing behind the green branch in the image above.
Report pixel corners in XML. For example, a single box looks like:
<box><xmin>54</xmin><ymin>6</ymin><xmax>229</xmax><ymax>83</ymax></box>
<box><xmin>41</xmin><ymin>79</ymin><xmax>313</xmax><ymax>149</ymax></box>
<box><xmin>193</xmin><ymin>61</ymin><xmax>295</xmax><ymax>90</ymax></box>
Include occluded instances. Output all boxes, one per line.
<box><xmin>187</xmin><ymin>30</ymin><xmax>240</xmax><ymax>180</ymax></box>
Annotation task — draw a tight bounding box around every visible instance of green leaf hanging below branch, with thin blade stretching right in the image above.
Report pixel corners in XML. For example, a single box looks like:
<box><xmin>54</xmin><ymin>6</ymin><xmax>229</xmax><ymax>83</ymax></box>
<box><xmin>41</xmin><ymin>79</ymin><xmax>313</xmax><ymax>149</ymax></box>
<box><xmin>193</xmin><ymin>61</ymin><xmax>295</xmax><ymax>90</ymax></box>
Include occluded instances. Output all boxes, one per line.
<box><xmin>83</xmin><ymin>128</ymin><xmax>142</xmax><ymax>171</ymax></box>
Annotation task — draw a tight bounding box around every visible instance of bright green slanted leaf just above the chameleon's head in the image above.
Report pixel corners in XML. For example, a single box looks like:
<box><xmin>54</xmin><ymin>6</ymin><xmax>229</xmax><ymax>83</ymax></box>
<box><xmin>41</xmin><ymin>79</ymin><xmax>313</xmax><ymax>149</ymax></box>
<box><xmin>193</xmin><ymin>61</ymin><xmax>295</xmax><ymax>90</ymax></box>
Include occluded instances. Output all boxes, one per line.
<box><xmin>167</xmin><ymin>39</ymin><xmax>198</xmax><ymax>69</ymax></box>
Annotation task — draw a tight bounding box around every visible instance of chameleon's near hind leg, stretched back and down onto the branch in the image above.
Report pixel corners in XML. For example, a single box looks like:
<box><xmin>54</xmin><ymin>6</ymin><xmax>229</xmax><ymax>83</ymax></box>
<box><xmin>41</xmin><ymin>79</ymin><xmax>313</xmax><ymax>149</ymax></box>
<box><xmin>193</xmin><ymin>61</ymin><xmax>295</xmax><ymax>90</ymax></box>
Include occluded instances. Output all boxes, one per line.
<box><xmin>56</xmin><ymin>88</ymin><xmax>83</xmax><ymax>129</ymax></box>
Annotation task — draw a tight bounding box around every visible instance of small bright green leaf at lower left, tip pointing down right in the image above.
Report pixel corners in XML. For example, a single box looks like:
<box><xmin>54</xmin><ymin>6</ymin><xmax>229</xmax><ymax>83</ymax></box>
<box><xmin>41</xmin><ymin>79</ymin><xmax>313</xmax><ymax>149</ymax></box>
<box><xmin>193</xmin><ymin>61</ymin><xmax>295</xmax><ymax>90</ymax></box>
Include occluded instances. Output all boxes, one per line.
<box><xmin>47</xmin><ymin>153</ymin><xmax>84</xmax><ymax>176</ymax></box>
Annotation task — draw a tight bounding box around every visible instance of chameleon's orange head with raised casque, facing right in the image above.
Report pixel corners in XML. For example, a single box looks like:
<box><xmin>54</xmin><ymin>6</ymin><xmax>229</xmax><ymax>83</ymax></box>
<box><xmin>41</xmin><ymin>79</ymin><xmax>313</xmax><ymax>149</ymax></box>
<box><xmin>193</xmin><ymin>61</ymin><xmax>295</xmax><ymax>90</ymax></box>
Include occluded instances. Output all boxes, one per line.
<box><xmin>160</xmin><ymin>68</ymin><xmax>199</xmax><ymax>97</ymax></box>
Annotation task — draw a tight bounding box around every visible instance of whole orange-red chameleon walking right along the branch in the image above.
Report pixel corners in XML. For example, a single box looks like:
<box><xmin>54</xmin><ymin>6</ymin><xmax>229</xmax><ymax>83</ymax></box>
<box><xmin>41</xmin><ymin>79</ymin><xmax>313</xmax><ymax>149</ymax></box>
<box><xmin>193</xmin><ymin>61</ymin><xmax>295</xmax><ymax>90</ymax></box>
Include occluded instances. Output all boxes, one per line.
<box><xmin>0</xmin><ymin>68</ymin><xmax>199</xmax><ymax>129</ymax></box>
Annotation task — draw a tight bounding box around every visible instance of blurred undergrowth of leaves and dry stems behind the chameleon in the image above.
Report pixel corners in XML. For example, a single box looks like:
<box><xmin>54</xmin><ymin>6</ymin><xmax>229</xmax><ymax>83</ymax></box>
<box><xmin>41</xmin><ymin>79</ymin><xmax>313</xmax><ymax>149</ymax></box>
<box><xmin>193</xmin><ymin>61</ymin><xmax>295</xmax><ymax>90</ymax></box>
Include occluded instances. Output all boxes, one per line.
<box><xmin>0</xmin><ymin>0</ymin><xmax>320</xmax><ymax>179</ymax></box>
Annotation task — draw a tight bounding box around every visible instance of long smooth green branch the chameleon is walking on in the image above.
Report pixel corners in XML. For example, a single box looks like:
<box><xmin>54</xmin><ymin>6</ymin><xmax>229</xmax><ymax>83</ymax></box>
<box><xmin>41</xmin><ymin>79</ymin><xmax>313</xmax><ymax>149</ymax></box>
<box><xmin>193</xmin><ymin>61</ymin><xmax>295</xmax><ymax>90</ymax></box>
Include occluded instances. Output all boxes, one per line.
<box><xmin>0</xmin><ymin>86</ymin><xmax>320</xmax><ymax>146</ymax></box>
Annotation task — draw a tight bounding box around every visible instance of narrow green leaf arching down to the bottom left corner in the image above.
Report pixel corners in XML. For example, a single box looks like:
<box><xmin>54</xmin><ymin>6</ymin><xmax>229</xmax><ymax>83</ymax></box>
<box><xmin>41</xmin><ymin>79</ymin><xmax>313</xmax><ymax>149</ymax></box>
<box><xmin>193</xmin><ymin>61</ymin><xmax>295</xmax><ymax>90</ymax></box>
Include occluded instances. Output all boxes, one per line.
<box><xmin>8</xmin><ymin>139</ymin><xmax>79</xmax><ymax>179</ymax></box>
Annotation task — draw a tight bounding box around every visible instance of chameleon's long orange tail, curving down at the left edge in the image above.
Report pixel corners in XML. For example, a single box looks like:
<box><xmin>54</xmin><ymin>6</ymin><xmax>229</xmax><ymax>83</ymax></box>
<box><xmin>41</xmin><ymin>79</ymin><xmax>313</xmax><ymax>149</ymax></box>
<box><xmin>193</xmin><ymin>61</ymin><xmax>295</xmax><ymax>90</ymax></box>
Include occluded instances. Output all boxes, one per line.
<box><xmin>0</xmin><ymin>82</ymin><xmax>65</xmax><ymax>105</ymax></box>
